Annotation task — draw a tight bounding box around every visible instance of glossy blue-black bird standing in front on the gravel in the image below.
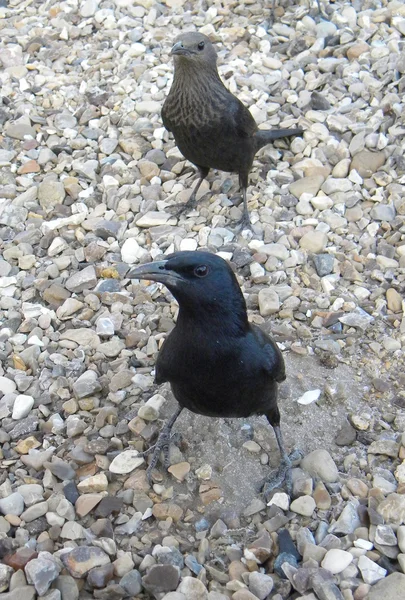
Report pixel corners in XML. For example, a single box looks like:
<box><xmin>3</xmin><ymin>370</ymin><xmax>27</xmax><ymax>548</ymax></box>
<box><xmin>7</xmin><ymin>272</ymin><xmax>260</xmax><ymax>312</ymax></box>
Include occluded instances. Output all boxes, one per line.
<box><xmin>128</xmin><ymin>252</ymin><xmax>291</xmax><ymax>490</ymax></box>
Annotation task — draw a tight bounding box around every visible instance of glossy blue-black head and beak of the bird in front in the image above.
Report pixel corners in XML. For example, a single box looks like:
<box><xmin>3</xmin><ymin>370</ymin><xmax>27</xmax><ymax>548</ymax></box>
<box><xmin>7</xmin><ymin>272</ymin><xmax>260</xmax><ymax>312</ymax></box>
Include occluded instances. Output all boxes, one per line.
<box><xmin>128</xmin><ymin>252</ymin><xmax>247</xmax><ymax>329</ymax></box>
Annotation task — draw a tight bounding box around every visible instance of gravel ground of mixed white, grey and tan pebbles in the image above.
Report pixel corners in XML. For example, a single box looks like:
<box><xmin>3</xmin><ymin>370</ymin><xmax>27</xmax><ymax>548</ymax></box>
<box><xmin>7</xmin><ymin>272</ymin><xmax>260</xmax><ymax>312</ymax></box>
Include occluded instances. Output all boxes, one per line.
<box><xmin>0</xmin><ymin>0</ymin><xmax>405</xmax><ymax>600</ymax></box>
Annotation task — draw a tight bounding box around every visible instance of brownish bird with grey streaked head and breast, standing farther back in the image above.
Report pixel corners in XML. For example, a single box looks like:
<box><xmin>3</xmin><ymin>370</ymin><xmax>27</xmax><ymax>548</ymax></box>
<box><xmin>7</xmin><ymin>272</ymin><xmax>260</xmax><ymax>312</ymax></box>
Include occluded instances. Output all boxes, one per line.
<box><xmin>162</xmin><ymin>32</ymin><xmax>302</xmax><ymax>226</ymax></box>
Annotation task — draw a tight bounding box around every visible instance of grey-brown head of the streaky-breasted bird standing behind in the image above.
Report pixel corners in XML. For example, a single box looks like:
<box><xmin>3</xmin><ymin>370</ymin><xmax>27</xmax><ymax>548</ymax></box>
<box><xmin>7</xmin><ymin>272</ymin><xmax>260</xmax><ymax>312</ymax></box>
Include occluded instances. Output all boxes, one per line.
<box><xmin>170</xmin><ymin>31</ymin><xmax>217</xmax><ymax>68</ymax></box>
